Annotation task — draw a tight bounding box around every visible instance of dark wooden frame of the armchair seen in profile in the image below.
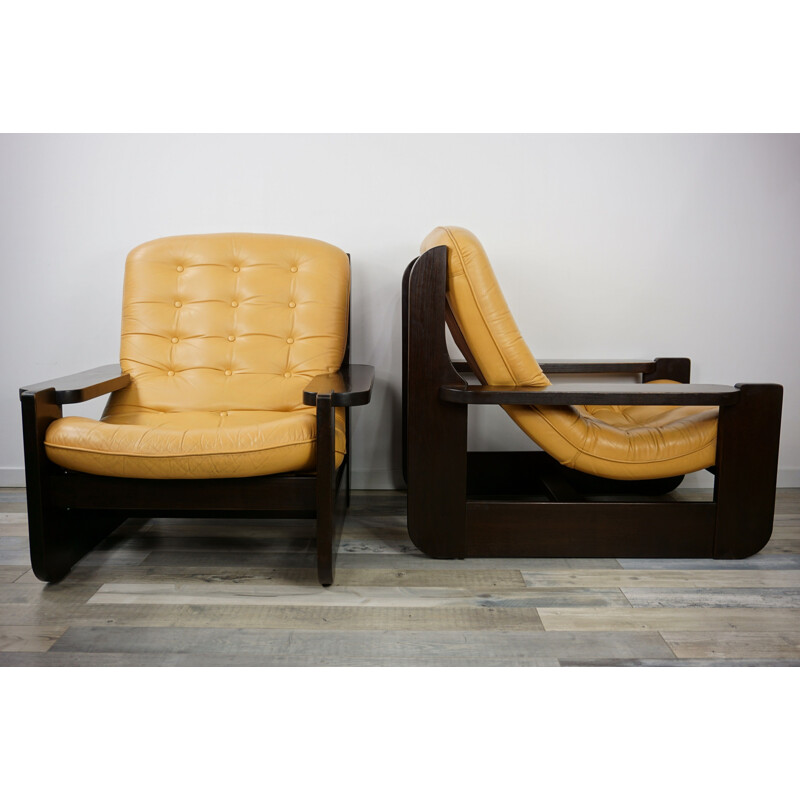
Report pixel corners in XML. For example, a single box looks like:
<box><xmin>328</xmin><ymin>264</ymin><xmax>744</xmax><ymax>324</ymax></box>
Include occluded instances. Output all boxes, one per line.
<box><xmin>402</xmin><ymin>246</ymin><xmax>783</xmax><ymax>558</ymax></box>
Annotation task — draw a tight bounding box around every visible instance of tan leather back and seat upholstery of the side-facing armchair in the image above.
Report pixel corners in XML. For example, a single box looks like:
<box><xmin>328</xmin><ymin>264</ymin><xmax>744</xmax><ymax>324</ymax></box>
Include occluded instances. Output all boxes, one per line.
<box><xmin>421</xmin><ymin>227</ymin><xmax>718</xmax><ymax>480</ymax></box>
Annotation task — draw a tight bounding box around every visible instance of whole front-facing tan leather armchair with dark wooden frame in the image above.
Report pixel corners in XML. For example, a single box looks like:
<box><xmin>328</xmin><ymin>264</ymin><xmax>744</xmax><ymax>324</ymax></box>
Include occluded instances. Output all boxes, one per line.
<box><xmin>20</xmin><ymin>234</ymin><xmax>373</xmax><ymax>585</ymax></box>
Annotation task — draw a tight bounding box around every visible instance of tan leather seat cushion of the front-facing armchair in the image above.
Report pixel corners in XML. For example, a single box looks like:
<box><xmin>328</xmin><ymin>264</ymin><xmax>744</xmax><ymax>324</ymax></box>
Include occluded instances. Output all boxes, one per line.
<box><xmin>45</xmin><ymin>408</ymin><xmax>345</xmax><ymax>479</ymax></box>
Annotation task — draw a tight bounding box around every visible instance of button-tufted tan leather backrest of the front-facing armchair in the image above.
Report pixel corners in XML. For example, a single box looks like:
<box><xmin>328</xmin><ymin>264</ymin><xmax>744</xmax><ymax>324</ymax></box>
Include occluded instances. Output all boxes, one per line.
<box><xmin>107</xmin><ymin>233</ymin><xmax>350</xmax><ymax>414</ymax></box>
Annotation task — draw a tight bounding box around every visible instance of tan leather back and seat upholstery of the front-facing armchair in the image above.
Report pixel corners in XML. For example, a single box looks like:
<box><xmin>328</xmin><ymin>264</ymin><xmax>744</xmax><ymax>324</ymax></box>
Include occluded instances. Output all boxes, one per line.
<box><xmin>45</xmin><ymin>234</ymin><xmax>350</xmax><ymax>478</ymax></box>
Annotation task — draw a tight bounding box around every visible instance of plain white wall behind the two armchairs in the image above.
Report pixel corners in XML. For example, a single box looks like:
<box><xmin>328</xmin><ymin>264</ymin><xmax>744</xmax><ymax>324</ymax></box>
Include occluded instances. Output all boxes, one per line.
<box><xmin>0</xmin><ymin>134</ymin><xmax>800</xmax><ymax>488</ymax></box>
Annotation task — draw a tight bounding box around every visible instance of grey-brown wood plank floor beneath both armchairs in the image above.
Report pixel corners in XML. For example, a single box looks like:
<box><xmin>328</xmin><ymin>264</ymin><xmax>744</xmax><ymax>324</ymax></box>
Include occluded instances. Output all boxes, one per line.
<box><xmin>0</xmin><ymin>489</ymin><xmax>800</xmax><ymax>667</ymax></box>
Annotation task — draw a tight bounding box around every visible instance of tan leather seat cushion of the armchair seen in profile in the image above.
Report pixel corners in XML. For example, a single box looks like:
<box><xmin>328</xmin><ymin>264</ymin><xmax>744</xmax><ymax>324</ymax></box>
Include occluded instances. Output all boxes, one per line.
<box><xmin>506</xmin><ymin>390</ymin><xmax>718</xmax><ymax>480</ymax></box>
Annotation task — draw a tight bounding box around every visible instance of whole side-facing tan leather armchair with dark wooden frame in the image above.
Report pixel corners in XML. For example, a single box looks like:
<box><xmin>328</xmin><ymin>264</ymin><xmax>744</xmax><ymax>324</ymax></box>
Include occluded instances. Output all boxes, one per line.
<box><xmin>403</xmin><ymin>227</ymin><xmax>783</xmax><ymax>558</ymax></box>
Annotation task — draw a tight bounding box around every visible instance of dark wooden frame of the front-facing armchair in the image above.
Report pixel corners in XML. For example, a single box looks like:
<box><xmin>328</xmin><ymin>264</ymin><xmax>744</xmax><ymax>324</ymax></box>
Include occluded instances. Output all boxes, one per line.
<box><xmin>20</xmin><ymin>308</ymin><xmax>374</xmax><ymax>586</ymax></box>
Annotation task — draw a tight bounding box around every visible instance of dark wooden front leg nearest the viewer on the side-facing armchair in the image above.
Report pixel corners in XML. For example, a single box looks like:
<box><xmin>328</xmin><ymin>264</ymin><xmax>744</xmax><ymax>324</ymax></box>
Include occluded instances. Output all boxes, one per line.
<box><xmin>714</xmin><ymin>384</ymin><xmax>783</xmax><ymax>558</ymax></box>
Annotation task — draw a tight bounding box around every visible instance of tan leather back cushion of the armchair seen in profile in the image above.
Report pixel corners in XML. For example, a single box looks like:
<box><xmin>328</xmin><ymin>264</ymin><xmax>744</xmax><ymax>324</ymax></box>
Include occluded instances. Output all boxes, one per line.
<box><xmin>420</xmin><ymin>227</ymin><xmax>550</xmax><ymax>386</ymax></box>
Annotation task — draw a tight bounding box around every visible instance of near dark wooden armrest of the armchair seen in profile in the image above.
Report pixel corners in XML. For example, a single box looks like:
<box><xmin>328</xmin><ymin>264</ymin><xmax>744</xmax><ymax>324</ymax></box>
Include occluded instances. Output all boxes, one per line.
<box><xmin>439</xmin><ymin>383</ymin><xmax>739</xmax><ymax>406</ymax></box>
